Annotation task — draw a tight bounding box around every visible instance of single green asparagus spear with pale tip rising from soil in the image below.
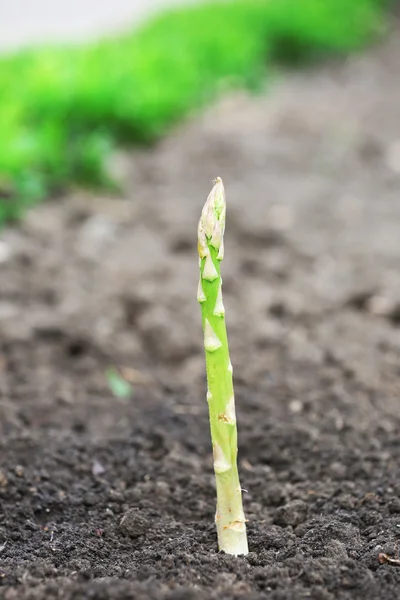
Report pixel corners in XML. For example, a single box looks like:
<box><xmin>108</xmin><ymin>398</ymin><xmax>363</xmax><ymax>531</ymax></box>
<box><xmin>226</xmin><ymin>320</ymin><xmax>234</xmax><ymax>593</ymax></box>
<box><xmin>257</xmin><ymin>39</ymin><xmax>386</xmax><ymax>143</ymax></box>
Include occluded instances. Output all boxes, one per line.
<box><xmin>197</xmin><ymin>178</ymin><xmax>248</xmax><ymax>556</ymax></box>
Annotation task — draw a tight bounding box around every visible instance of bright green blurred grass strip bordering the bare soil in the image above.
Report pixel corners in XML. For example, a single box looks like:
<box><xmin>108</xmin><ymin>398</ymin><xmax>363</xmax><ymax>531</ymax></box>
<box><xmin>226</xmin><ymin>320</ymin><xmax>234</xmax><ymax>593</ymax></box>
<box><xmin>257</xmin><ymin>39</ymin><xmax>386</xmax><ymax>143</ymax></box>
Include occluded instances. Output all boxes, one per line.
<box><xmin>0</xmin><ymin>0</ymin><xmax>384</xmax><ymax>222</ymax></box>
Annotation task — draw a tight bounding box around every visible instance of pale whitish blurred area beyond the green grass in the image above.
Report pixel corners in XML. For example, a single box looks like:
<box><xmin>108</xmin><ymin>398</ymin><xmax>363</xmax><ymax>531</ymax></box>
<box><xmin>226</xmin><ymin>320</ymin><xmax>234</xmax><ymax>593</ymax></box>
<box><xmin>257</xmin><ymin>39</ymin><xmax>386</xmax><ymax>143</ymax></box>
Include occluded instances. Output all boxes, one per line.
<box><xmin>0</xmin><ymin>0</ymin><xmax>197</xmax><ymax>50</ymax></box>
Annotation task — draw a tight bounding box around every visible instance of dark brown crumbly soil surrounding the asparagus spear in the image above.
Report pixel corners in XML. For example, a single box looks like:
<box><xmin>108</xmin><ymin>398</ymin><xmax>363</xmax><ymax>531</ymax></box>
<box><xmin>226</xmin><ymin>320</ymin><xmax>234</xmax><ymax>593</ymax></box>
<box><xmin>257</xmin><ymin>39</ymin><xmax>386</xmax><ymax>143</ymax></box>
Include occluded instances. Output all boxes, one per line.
<box><xmin>0</xmin><ymin>24</ymin><xmax>400</xmax><ymax>600</ymax></box>
